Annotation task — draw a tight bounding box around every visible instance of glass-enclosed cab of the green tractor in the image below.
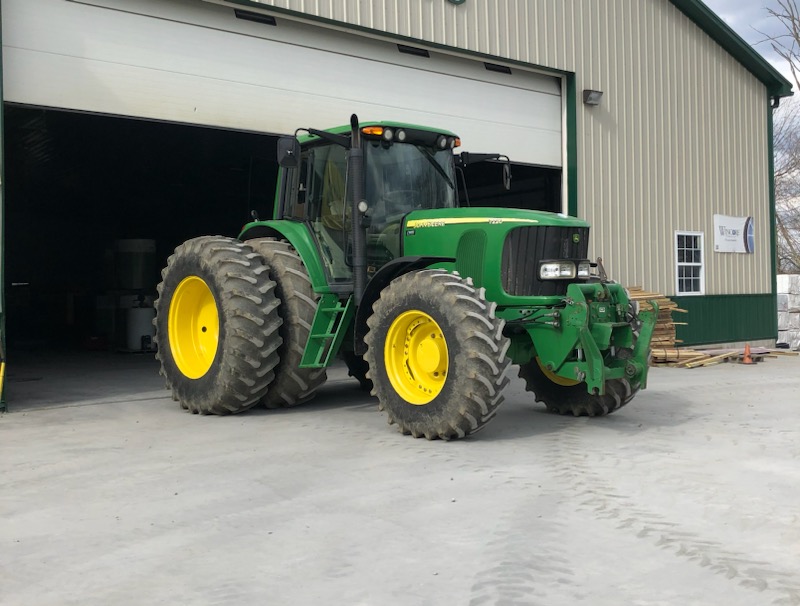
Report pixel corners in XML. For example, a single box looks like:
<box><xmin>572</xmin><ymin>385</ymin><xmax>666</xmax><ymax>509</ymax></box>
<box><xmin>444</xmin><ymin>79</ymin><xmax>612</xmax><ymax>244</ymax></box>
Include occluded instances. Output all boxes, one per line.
<box><xmin>276</xmin><ymin>123</ymin><xmax>459</xmax><ymax>283</ymax></box>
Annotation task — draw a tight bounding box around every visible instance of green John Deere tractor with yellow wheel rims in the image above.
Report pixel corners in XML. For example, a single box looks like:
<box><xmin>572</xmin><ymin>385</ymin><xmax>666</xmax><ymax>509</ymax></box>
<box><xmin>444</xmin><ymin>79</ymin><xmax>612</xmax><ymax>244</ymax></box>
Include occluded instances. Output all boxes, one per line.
<box><xmin>155</xmin><ymin>116</ymin><xmax>657</xmax><ymax>439</ymax></box>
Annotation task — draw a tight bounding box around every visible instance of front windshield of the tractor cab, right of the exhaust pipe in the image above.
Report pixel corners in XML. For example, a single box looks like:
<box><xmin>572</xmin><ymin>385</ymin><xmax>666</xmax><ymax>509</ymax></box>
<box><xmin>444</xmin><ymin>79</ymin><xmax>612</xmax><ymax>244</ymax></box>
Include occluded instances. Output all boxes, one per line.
<box><xmin>365</xmin><ymin>141</ymin><xmax>456</xmax><ymax>224</ymax></box>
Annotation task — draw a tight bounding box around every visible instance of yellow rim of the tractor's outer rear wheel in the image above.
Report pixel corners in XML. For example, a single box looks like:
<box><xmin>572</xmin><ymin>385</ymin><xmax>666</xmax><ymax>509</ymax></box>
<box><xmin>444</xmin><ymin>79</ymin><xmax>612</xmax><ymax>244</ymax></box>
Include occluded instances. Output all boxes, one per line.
<box><xmin>168</xmin><ymin>276</ymin><xmax>219</xmax><ymax>379</ymax></box>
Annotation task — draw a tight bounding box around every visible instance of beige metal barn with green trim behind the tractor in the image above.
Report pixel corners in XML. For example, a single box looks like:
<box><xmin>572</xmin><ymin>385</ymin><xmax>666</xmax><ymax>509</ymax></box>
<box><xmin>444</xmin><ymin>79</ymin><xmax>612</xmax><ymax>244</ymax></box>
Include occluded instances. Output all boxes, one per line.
<box><xmin>0</xmin><ymin>0</ymin><xmax>791</xmax><ymax>408</ymax></box>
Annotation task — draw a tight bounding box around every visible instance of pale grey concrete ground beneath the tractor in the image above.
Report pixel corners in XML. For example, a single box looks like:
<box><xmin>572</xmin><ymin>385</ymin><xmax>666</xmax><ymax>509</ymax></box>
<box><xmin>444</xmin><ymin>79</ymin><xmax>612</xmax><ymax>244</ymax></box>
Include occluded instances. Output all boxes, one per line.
<box><xmin>0</xmin><ymin>354</ymin><xmax>800</xmax><ymax>606</ymax></box>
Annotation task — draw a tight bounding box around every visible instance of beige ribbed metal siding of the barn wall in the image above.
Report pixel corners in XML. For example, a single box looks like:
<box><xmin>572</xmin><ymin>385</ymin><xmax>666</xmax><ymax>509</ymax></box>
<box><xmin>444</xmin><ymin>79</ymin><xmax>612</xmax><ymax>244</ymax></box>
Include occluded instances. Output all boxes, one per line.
<box><xmin>242</xmin><ymin>0</ymin><xmax>771</xmax><ymax>294</ymax></box>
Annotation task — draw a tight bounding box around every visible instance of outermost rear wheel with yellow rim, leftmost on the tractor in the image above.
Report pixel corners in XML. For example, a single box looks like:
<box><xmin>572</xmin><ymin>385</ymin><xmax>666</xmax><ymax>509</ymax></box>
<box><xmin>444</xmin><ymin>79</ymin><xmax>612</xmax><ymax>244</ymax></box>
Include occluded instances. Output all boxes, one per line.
<box><xmin>154</xmin><ymin>236</ymin><xmax>281</xmax><ymax>414</ymax></box>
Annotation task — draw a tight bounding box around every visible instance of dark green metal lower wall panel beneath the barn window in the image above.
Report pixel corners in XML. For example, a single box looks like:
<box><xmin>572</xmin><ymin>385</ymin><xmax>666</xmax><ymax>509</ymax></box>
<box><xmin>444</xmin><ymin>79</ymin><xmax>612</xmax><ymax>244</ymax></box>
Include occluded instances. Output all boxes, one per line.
<box><xmin>670</xmin><ymin>294</ymin><xmax>778</xmax><ymax>347</ymax></box>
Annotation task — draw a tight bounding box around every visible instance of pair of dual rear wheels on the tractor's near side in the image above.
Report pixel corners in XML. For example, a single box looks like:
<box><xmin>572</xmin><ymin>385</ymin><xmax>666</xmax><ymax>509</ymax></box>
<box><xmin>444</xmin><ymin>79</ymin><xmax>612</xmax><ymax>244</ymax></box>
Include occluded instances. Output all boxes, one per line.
<box><xmin>155</xmin><ymin>236</ymin><xmax>326</xmax><ymax>414</ymax></box>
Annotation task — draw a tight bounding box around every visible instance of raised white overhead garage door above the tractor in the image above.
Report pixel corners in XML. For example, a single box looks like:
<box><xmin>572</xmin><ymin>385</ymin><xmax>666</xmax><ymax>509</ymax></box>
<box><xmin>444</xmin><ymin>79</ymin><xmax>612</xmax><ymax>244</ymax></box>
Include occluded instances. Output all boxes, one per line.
<box><xmin>2</xmin><ymin>0</ymin><xmax>563</xmax><ymax>167</ymax></box>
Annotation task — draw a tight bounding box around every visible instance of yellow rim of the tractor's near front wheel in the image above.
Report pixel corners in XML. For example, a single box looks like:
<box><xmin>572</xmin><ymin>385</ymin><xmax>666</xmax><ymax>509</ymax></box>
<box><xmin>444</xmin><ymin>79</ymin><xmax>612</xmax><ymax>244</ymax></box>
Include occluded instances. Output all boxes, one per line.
<box><xmin>384</xmin><ymin>310</ymin><xmax>449</xmax><ymax>406</ymax></box>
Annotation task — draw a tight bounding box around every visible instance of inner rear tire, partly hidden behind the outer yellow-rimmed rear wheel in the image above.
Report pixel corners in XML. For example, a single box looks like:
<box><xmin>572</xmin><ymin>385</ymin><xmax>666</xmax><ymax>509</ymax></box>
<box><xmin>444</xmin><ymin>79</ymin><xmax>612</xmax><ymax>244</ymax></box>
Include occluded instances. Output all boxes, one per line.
<box><xmin>246</xmin><ymin>238</ymin><xmax>327</xmax><ymax>408</ymax></box>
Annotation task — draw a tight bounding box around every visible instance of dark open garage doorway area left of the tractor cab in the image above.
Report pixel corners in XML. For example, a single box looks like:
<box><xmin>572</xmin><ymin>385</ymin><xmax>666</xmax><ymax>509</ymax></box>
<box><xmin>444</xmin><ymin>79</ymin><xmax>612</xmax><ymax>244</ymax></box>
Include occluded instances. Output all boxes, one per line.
<box><xmin>4</xmin><ymin>104</ymin><xmax>277</xmax><ymax>360</ymax></box>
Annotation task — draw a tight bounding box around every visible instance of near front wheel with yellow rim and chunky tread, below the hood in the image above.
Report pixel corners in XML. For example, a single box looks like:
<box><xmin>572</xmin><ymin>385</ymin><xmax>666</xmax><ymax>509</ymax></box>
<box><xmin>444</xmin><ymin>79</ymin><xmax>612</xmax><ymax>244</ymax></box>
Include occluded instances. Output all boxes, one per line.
<box><xmin>365</xmin><ymin>270</ymin><xmax>510</xmax><ymax>440</ymax></box>
